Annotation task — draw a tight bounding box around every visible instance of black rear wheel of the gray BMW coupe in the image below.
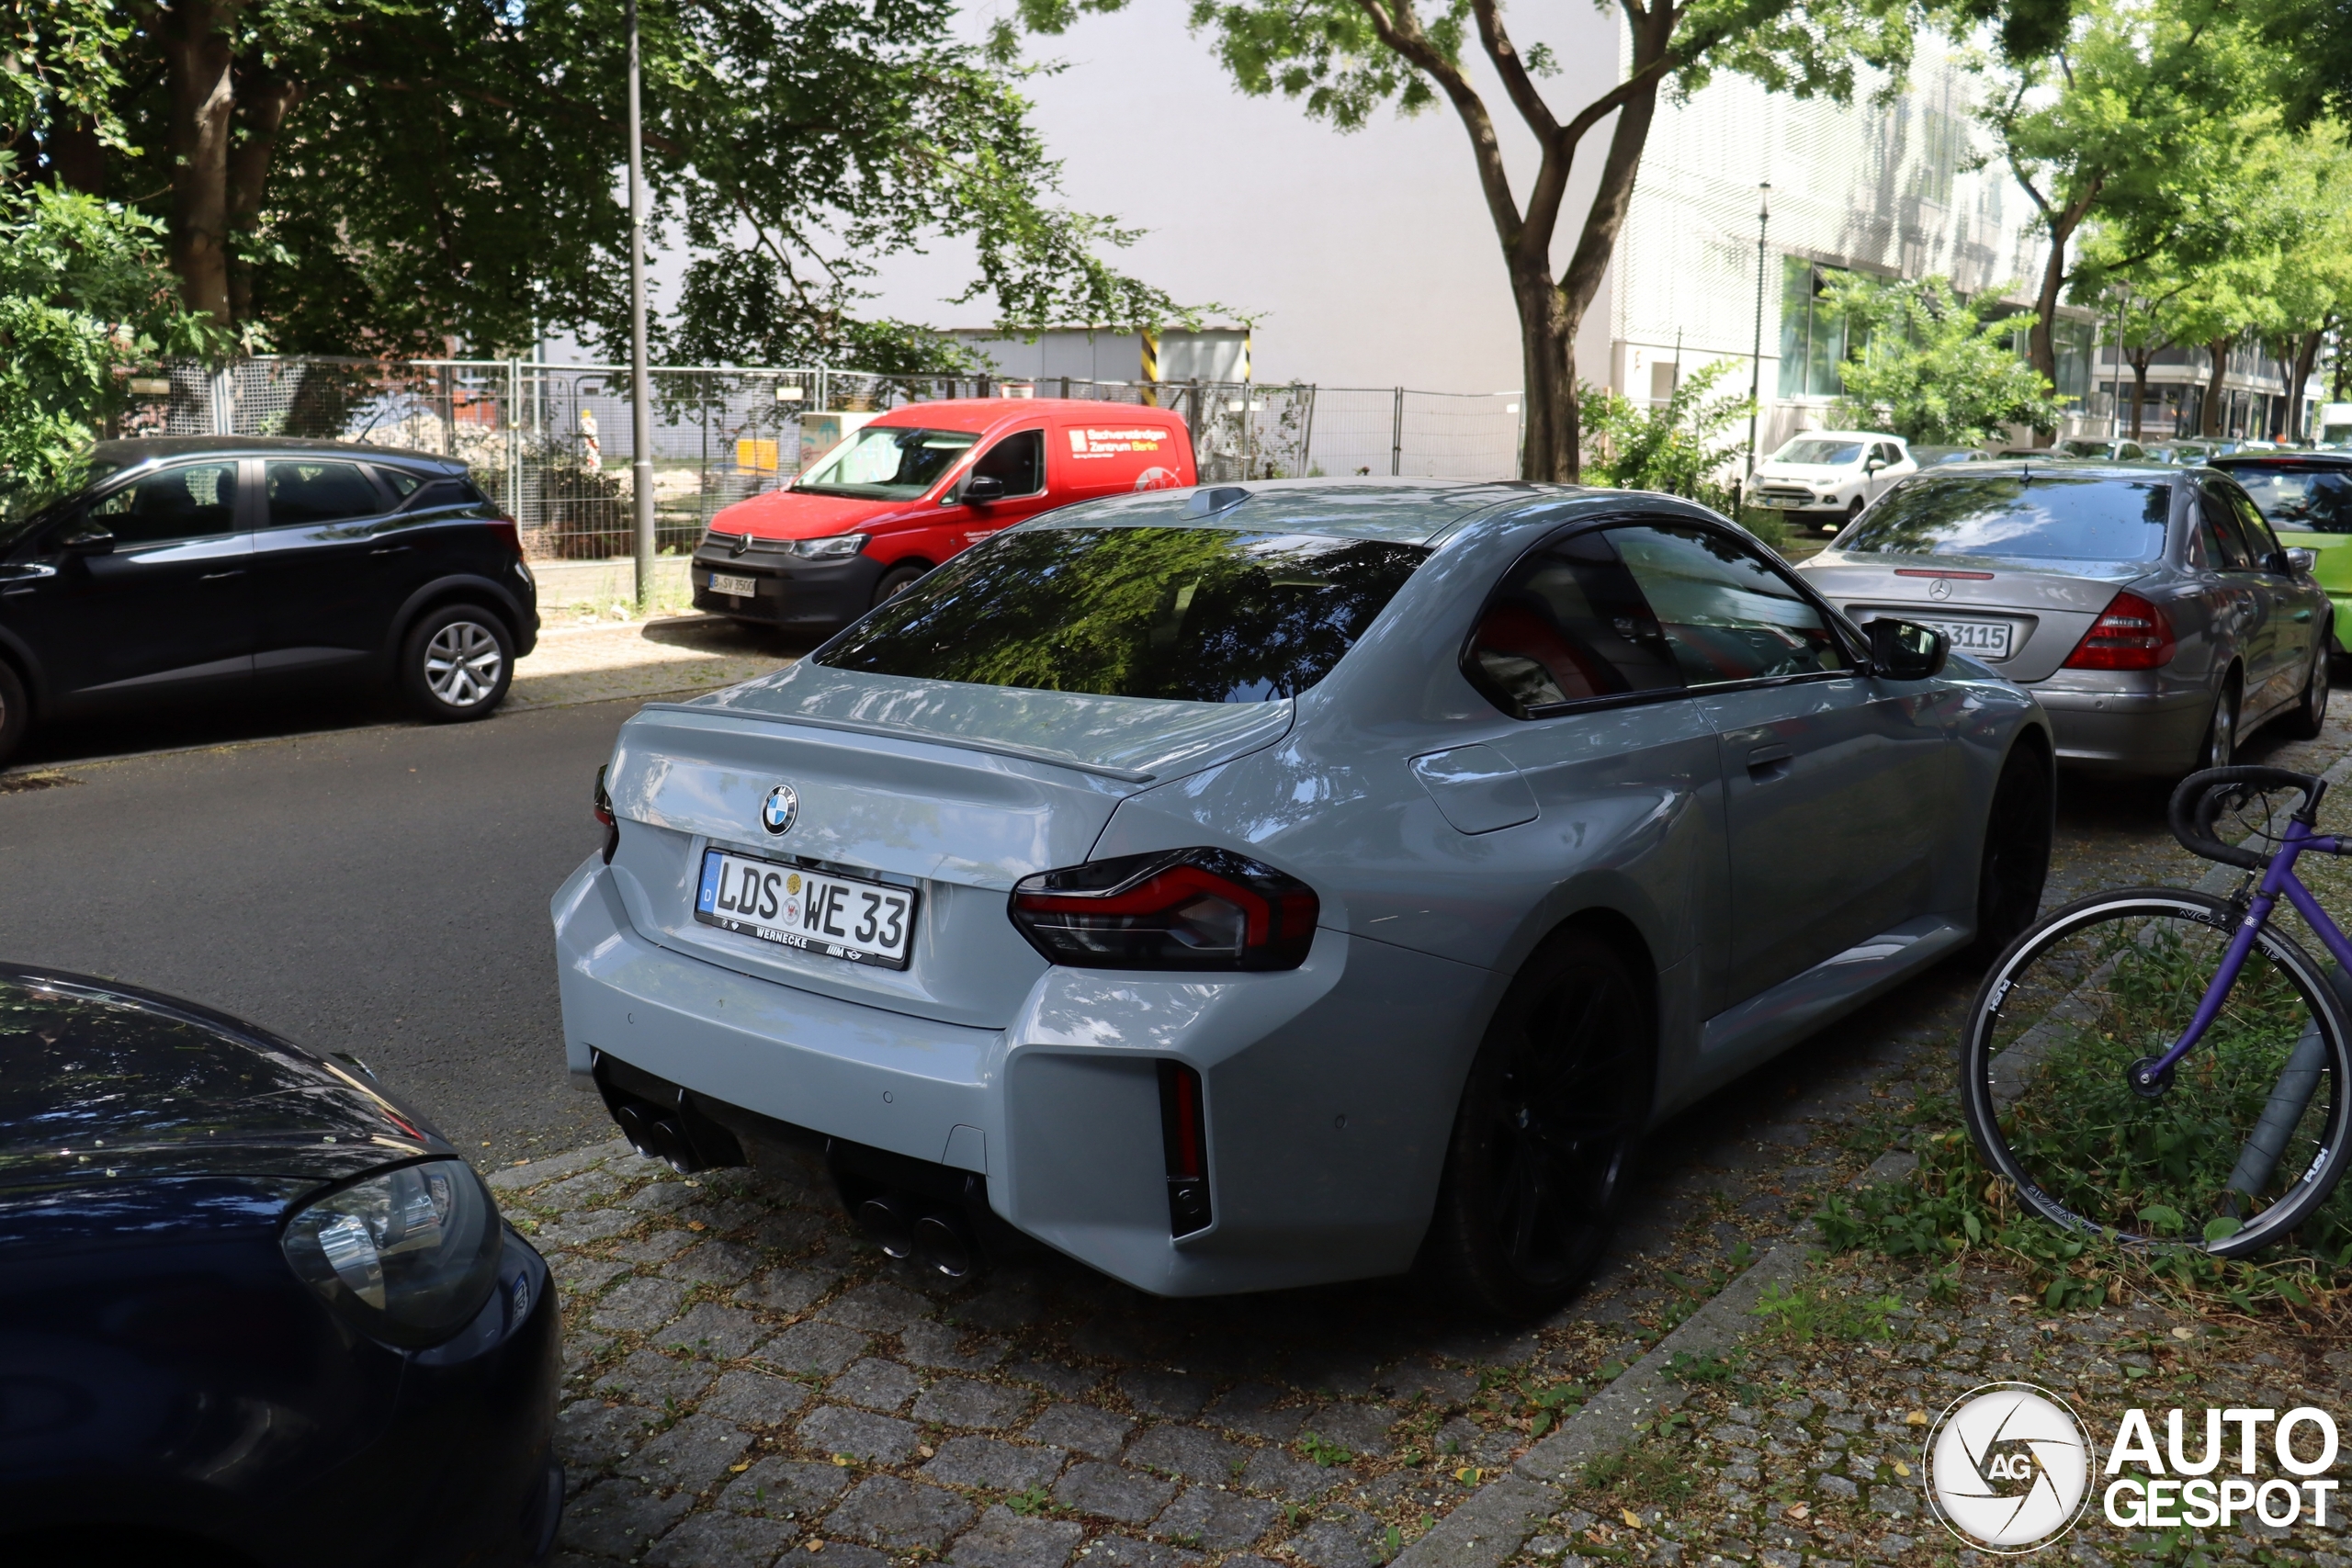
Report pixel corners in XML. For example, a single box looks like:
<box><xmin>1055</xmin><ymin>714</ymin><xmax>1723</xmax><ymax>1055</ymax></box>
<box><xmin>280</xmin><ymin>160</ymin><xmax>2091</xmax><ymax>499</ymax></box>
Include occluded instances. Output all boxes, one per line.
<box><xmin>1423</xmin><ymin>931</ymin><xmax>1656</xmax><ymax>1321</ymax></box>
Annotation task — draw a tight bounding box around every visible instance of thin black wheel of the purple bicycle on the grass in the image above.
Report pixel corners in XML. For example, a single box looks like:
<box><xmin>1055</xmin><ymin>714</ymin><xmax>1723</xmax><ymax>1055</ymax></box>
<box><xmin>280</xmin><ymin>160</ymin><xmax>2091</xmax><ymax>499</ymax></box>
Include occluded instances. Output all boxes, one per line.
<box><xmin>1959</xmin><ymin>888</ymin><xmax>2352</xmax><ymax>1258</ymax></box>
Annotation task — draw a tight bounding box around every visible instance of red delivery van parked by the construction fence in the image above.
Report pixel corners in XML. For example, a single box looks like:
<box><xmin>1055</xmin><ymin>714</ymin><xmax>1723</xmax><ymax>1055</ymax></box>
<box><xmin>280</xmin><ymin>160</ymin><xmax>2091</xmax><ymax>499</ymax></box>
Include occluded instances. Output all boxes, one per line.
<box><xmin>692</xmin><ymin>398</ymin><xmax>1197</xmax><ymax>632</ymax></box>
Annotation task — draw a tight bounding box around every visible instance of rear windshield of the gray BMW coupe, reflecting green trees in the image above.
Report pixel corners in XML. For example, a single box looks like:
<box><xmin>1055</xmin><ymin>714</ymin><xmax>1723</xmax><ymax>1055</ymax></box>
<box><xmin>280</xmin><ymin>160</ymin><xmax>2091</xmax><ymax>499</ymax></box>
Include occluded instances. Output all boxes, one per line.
<box><xmin>814</xmin><ymin>529</ymin><xmax>1428</xmax><ymax>703</ymax></box>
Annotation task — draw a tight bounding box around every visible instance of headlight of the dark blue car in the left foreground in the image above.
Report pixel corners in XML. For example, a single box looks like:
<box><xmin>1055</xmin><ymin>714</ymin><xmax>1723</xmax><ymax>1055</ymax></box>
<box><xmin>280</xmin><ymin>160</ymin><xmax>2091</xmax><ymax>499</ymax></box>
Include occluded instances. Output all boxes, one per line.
<box><xmin>280</xmin><ymin>1159</ymin><xmax>505</xmax><ymax>1349</ymax></box>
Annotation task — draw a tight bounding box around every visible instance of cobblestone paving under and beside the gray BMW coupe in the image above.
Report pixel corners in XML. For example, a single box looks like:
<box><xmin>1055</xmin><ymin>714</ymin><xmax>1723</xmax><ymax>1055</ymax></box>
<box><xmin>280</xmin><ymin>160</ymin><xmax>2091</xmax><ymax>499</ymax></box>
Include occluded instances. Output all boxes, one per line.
<box><xmin>494</xmin><ymin>709</ymin><xmax>2352</xmax><ymax>1568</ymax></box>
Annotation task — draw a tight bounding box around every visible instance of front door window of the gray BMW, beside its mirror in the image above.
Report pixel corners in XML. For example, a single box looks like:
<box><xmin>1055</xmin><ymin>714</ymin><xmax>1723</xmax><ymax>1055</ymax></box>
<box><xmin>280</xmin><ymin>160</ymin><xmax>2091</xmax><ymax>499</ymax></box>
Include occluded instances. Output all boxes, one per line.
<box><xmin>1609</xmin><ymin>525</ymin><xmax>1853</xmax><ymax>686</ymax></box>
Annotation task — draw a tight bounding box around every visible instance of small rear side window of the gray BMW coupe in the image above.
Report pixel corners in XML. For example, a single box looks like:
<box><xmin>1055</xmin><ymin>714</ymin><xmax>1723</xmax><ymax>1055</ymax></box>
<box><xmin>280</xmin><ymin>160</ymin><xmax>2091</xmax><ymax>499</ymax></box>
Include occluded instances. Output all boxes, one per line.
<box><xmin>1463</xmin><ymin>531</ymin><xmax>1681</xmax><ymax>719</ymax></box>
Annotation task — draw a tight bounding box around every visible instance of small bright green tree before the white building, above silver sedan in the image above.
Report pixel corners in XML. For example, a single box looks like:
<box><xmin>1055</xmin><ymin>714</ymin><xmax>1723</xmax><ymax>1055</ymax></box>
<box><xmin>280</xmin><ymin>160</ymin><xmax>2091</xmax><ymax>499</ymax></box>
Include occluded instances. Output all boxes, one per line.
<box><xmin>1823</xmin><ymin>273</ymin><xmax>2061</xmax><ymax>446</ymax></box>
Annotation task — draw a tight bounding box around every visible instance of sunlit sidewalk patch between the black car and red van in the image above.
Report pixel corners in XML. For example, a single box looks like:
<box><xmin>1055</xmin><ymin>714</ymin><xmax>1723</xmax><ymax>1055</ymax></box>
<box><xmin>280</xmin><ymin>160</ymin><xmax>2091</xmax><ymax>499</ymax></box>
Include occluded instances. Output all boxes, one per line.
<box><xmin>505</xmin><ymin>616</ymin><xmax>797</xmax><ymax>710</ymax></box>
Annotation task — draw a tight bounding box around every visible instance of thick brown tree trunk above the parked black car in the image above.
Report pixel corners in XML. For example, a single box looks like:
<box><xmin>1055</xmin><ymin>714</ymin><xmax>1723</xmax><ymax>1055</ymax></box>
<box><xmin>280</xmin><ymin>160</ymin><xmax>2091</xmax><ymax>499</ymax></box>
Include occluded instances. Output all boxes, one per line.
<box><xmin>163</xmin><ymin>0</ymin><xmax>238</xmax><ymax>327</ymax></box>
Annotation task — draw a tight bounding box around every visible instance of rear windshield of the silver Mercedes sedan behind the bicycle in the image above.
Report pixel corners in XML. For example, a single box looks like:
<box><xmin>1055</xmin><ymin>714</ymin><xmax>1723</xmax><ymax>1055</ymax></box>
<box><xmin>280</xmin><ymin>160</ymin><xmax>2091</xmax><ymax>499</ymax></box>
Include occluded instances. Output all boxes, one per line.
<box><xmin>1835</xmin><ymin>472</ymin><xmax>2173</xmax><ymax>562</ymax></box>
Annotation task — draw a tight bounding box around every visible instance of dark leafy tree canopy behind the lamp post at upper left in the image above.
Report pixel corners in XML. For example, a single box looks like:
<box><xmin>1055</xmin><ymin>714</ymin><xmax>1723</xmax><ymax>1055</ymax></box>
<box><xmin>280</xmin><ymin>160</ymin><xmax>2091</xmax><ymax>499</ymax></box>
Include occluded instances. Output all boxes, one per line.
<box><xmin>41</xmin><ymin>0</ymin><xmax>1193</xmax><ymax>369</ymax></box>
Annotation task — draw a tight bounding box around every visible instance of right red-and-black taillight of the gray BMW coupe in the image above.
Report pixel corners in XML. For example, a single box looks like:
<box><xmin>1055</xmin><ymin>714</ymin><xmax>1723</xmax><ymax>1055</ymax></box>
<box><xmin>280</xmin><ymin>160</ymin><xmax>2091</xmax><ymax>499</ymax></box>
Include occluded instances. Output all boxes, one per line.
<box><xmin>1012</xmin><ymin>849</ymin><xmax>1322</xmax><ymax>968</ymax></box>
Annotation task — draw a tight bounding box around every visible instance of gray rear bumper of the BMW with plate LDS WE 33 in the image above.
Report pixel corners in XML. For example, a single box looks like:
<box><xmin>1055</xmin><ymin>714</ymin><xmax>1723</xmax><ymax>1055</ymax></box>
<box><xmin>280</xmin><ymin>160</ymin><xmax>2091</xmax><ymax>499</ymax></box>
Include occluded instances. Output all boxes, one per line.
<box><xmin>553</xmin><ymin>858</ymin><xmax>1503</xmax><ymax>1295</ymax></box>
